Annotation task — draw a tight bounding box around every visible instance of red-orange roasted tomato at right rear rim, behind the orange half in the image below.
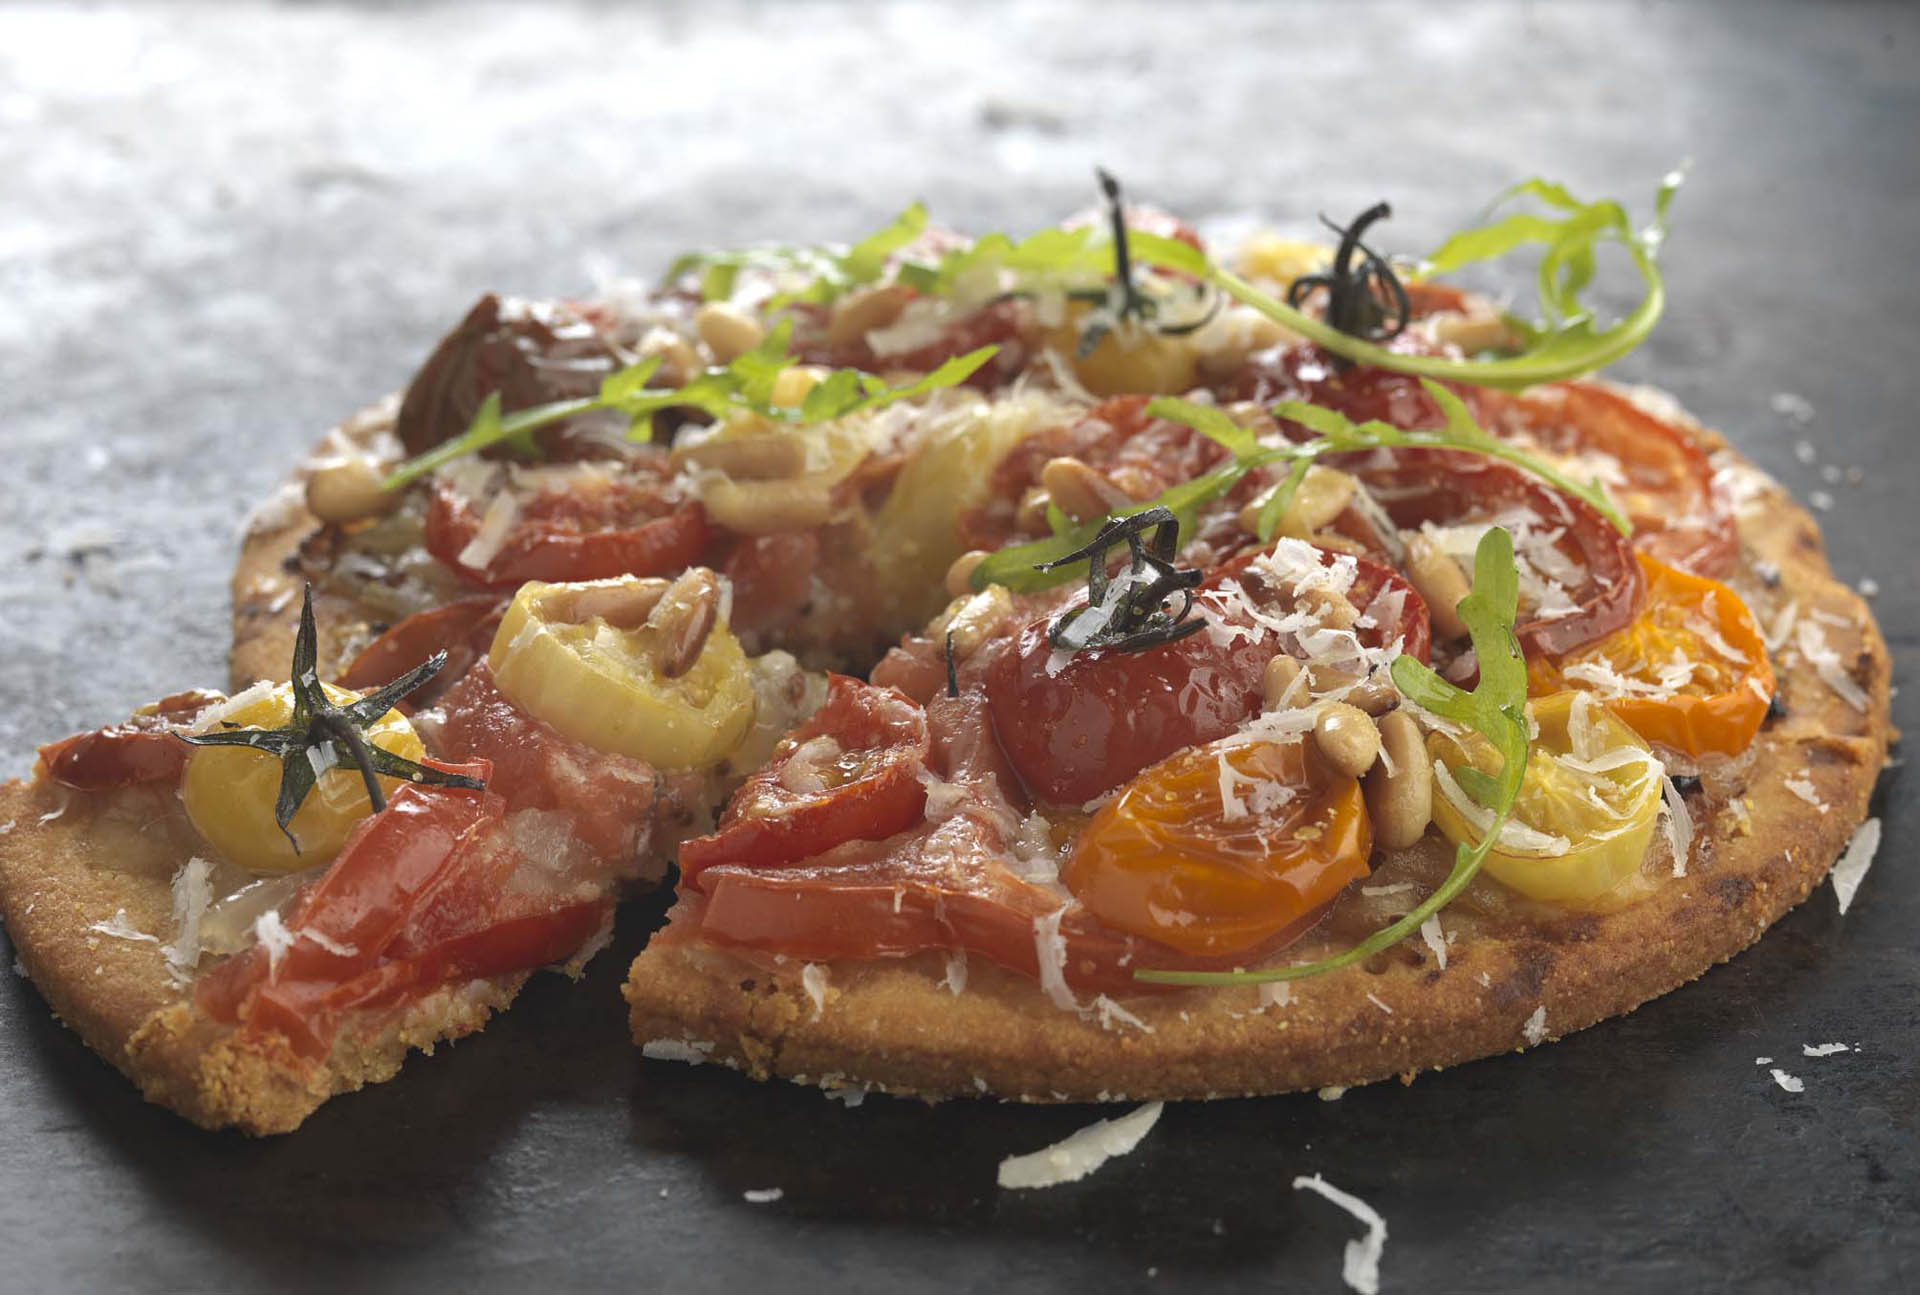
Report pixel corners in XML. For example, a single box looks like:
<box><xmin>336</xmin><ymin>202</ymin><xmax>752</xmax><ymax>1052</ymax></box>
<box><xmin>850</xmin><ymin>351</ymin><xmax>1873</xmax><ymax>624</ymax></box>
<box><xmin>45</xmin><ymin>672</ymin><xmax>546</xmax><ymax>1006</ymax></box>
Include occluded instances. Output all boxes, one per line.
<box><xmin>1486</xmin><ymin>382</ymin><xmax>1740</xmax><ymax>576</ymax></box>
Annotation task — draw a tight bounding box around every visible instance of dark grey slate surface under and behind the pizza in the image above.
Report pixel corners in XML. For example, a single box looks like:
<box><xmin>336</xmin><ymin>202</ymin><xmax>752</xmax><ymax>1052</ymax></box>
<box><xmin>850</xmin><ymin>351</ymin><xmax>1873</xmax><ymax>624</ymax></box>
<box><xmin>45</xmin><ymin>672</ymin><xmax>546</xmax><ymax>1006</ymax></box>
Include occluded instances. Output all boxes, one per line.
<box><xmin>0</xmin><ymin>4</ymin><xmax>1920</xmax><ymax>1291</ymax></box>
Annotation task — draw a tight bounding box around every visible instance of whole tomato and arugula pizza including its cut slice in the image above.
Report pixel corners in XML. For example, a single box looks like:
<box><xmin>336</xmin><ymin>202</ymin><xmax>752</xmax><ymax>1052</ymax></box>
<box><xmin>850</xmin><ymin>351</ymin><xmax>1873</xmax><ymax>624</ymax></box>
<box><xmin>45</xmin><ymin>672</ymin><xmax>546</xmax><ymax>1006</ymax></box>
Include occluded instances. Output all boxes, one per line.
<box><xmin>0</xmin><ymin>177</ymin><xmax>1889</xmax><ymax>1132</ymax></box>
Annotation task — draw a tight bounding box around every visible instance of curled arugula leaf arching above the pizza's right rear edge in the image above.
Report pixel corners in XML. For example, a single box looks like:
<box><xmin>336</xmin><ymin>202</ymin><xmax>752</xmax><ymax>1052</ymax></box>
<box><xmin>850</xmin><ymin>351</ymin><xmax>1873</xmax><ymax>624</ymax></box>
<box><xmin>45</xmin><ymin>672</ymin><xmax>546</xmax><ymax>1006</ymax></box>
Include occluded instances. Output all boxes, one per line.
<box><xmin>1135</xmin><ymin>169</ymin><xmax>1684</xmax><ymax>390</ymax></box>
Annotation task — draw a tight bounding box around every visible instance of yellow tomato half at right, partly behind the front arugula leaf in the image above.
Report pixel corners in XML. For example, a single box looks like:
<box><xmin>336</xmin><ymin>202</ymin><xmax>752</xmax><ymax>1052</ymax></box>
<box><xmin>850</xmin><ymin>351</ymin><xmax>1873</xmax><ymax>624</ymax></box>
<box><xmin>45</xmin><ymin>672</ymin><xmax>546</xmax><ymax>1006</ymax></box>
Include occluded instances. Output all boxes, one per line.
<box><xmin>1427</xmin><ymin>692</ymin><xmax>1665</xmax><ymax>907</ymax></box>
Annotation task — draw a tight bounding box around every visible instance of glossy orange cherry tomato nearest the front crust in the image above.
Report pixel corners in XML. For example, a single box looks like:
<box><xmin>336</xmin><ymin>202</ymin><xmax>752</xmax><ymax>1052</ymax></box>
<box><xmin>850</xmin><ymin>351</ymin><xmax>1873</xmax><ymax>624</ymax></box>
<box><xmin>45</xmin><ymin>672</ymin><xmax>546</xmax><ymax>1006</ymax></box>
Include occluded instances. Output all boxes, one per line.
<box><xmin>1060</xmin><ymin>742</ymin><xmax>1373</xmax><ymax>955</ymax></box>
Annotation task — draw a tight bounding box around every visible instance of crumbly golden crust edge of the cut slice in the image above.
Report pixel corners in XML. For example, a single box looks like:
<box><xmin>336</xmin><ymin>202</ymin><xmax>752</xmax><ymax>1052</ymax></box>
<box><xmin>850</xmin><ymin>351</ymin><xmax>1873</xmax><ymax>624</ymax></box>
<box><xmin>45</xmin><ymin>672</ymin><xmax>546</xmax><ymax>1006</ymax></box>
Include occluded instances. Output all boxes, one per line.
<box><xmin>0</xmin><ymin>778</ymin><xmax>526</xmax><ymax>1134</ymax></box>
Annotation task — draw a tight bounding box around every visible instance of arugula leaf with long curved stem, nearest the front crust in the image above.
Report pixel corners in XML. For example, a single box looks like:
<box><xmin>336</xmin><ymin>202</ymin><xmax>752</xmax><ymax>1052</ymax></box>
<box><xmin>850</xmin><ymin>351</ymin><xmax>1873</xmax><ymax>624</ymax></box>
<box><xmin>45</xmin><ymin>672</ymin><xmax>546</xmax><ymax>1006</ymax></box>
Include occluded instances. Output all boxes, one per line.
<box><xmin>1133</xmin><ymin>526</ymin><xmax>1528</xmax><ymax>986</ymax></box>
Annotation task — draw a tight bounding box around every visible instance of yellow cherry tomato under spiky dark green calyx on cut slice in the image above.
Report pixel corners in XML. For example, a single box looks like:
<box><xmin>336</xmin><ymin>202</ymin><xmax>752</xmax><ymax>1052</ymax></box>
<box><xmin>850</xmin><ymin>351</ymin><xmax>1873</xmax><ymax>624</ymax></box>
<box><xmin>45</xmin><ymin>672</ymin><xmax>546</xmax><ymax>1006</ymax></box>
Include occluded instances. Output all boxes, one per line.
<box><xmin>180</xmin><ymin>684</ymin><xmax>426</xmax><ymax>872</ymax></box>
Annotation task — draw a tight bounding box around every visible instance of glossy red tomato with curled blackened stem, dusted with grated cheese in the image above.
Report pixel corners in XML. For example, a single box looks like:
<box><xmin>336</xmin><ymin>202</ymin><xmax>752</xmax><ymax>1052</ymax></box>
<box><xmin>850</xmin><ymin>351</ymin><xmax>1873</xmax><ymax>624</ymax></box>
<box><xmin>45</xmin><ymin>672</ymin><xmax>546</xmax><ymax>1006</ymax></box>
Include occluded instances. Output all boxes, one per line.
<box><xmin>987</xmin><ymin>542</ymin><xmax>1428</xmax><ymax>805</ymax></box>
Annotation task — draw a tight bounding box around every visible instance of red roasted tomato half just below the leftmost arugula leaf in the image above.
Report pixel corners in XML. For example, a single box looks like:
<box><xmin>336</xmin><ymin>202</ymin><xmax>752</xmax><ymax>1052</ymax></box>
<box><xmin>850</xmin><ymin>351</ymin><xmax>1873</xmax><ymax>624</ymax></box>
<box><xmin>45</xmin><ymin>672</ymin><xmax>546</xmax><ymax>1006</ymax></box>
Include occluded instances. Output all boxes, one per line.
<box><xmin>426</xmin><ymin>465</ymin><xmax>708</xmax><ymax>588</ymax></box>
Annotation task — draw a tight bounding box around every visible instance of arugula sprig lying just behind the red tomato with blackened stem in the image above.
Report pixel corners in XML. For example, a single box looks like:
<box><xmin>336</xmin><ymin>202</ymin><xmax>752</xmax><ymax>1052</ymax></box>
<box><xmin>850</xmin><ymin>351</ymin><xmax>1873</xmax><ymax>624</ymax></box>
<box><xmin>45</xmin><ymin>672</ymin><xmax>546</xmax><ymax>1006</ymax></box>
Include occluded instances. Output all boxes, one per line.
<box><xmin>972</xmin><ymin>376</ymin><xmax>1632</xmax><ymax>594</ymax></box>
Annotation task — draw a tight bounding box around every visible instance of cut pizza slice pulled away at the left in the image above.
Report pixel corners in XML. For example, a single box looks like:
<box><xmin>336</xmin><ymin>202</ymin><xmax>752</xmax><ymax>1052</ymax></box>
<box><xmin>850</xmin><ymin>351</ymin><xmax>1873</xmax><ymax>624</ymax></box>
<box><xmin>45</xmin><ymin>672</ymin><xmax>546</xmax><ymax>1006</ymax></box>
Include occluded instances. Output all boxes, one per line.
<box><xmin>0</xmin><ymin>571</ymin><xmax>818</xmax><ymax>1134</ymax></box>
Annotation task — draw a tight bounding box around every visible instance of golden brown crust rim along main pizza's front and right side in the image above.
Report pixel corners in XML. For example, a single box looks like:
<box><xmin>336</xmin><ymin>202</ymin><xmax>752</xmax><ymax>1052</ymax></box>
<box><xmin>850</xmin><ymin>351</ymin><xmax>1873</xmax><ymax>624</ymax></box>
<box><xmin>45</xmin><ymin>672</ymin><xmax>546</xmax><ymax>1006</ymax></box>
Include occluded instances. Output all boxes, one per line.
<box><xmin>626</xmin><ymin>422</ymin><xmax>1891</xmax><ymax>1101</ymax></box>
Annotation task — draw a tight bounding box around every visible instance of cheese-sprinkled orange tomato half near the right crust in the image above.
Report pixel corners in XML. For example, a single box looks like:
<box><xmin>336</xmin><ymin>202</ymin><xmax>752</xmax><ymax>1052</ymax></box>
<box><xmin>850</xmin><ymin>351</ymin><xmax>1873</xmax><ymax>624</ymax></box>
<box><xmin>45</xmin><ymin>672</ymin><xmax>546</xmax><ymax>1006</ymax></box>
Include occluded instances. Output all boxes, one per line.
<box><xmin>1526</xmin><ymin>553</ymin><xmax>1774</xmax><ymax>755</ymax></box>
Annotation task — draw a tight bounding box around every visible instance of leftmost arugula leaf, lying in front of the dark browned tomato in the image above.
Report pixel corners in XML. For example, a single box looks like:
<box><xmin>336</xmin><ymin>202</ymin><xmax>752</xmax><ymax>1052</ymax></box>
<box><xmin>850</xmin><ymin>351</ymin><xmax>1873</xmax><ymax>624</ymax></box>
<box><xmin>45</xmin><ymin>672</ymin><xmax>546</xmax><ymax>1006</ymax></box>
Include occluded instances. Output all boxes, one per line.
<box><xmin>380</xmin><ymin>328</ymin><xmax>1000</xmax><ymax>490</ymax></box>
